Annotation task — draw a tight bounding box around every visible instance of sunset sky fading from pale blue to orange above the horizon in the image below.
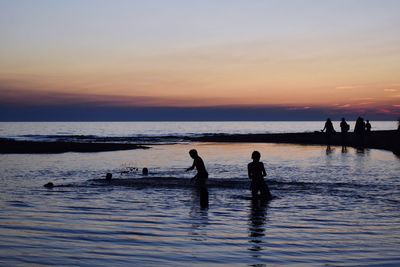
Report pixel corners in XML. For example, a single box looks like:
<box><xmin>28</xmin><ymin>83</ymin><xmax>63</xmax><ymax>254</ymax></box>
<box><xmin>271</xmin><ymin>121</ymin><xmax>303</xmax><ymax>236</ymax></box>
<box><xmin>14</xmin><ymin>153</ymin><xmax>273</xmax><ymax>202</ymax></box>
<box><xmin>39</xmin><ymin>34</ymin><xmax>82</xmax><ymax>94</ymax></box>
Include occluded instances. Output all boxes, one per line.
<box><xmin>0</xmin><ymin>0</ymin><xmax>400</xmax><ymax>120</ymax></box>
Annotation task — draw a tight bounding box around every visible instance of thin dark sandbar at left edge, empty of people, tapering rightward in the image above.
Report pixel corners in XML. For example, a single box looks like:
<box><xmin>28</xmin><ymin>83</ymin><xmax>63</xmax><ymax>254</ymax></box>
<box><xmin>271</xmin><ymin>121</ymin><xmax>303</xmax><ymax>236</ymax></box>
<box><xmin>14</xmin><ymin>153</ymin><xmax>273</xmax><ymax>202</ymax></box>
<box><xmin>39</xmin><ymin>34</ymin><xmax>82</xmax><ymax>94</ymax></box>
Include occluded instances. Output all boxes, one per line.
<box><xmin>0</xmin><ymin>139</ymin><xmax>149</xmax><ymax>154</ymax></box>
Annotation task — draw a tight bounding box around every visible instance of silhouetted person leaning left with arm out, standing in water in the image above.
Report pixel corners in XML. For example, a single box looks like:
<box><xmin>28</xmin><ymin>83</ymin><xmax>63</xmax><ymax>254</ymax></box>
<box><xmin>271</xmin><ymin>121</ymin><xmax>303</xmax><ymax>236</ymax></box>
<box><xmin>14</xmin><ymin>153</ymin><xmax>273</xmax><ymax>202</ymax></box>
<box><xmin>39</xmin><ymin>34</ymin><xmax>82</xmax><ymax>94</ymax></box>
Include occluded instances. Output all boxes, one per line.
<box><xmin>186</xmin><ymin>149</ymin><xmax>208</xmax><ymax>208</ymax></box>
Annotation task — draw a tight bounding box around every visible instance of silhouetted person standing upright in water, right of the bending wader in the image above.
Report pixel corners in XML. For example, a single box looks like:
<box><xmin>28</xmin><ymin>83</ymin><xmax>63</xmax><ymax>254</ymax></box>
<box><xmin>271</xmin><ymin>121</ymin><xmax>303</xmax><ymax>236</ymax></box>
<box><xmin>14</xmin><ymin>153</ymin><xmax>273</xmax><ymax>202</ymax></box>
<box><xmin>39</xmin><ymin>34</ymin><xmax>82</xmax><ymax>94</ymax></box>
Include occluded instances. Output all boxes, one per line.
<box><xmin>247</xmin><ymin>151</ymin><xmax>272</xmax><ymax>200</ymax></box>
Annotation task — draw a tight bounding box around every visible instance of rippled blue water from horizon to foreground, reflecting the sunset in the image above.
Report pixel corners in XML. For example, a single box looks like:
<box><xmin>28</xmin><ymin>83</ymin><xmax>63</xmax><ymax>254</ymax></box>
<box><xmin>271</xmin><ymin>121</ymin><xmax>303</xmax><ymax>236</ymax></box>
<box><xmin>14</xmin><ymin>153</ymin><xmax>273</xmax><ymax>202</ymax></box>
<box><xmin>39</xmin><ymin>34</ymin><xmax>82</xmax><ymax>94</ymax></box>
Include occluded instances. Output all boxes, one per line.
<box><xmin>0</xmin><ymin>121</ymin><xmax>400</xmax><ymax>266</ymax></box>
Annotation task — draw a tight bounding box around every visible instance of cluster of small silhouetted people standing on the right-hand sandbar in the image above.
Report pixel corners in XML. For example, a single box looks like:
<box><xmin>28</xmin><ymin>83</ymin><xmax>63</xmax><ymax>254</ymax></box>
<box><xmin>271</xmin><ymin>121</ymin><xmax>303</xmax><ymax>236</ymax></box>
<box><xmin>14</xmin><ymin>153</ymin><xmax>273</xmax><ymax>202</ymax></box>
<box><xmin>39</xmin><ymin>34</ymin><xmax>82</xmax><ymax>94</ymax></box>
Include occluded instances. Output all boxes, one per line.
<box><xmin>321</xmin><ymin>117</ymin><xmax>372</xmax><ymax>148</ymax></box>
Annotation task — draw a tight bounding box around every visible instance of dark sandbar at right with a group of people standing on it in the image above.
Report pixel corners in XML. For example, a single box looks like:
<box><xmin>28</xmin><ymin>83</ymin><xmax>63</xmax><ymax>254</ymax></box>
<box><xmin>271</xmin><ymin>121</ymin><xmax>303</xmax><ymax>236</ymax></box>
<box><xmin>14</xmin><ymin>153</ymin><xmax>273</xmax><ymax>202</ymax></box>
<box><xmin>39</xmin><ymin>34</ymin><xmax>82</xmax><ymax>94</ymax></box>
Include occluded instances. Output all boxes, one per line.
<box><xmin>191</xmin><ymin>130</ymin><xmax>400</xmax><ymax>155</ymax></box>
